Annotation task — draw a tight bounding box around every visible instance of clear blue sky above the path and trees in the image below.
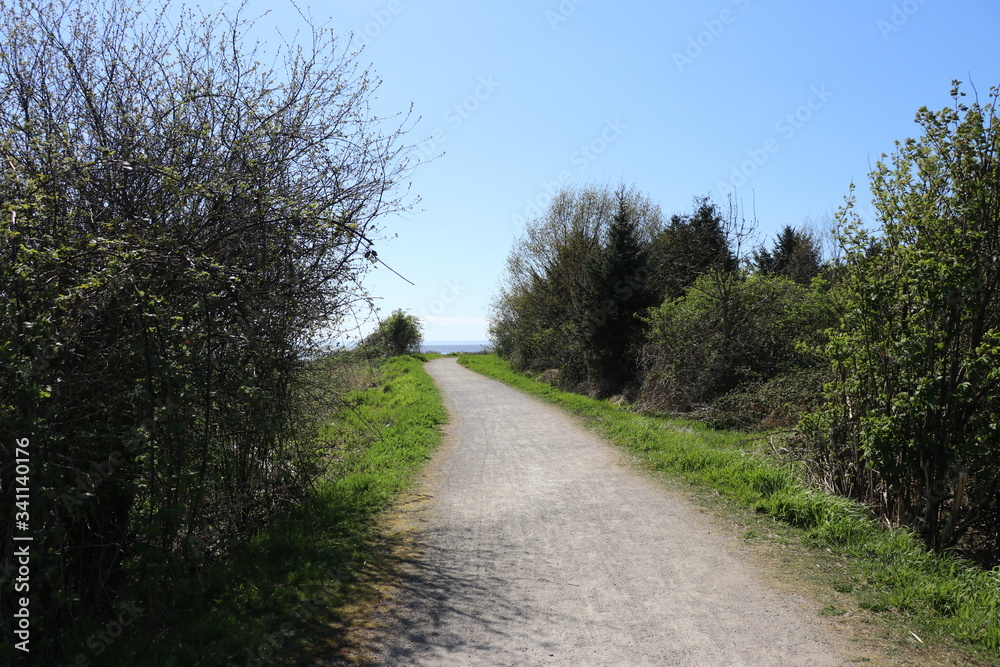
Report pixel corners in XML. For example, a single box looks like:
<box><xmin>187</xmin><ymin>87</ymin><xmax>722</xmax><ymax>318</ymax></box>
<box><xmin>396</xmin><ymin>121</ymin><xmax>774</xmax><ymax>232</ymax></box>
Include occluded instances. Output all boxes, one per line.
<box><xmin>234</xmin><ymin>0</ymin><xmax>1000</xmax><ymax>341</ymax></box>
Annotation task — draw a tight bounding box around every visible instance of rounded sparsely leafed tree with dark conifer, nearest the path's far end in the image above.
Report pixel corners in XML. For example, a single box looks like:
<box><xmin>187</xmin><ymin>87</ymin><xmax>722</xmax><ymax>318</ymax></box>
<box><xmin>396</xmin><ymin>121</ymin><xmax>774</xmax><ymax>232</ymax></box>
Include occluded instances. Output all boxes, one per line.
<box><xmin>490</xmin><ymin>188</ymin><xmax>662</xmax><ymax>392</ymax></box>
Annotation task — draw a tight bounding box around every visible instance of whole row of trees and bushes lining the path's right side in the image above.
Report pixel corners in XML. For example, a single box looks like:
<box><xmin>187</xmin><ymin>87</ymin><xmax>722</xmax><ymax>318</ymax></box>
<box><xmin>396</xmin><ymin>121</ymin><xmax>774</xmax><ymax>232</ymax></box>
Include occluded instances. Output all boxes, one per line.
<box><xmin>490</xmin><ymin>82</ymin><xmax>1000</xmax><ymax>572</ymax></box>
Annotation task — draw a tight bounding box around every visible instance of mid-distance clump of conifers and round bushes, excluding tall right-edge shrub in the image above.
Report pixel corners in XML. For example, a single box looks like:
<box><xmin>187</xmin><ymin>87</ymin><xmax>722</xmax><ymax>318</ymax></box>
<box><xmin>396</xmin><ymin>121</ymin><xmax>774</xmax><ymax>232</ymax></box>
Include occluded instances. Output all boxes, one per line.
<box><xmin>491</xmin><ymin>188</ymin><xmax>833</xmax><ymax>424</ymax></box>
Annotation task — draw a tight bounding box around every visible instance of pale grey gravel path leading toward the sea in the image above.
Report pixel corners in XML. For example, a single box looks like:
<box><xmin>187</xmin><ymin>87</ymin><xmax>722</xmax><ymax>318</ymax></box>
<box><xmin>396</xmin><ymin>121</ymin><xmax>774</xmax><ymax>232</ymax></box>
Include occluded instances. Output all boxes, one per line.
<box><xmin>372</xmin><ymin>359</ymin><xmax>845</xmax><ymax>666</ymax></box>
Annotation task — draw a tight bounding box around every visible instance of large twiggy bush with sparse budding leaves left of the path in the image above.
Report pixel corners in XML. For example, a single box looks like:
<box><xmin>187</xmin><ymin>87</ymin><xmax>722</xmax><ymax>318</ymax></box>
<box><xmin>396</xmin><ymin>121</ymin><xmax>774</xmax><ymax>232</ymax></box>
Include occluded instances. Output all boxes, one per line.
<box><xmin>0</xmin><ymin>0</ymin><xmax>408</xmax><ymax>660</ymax></box>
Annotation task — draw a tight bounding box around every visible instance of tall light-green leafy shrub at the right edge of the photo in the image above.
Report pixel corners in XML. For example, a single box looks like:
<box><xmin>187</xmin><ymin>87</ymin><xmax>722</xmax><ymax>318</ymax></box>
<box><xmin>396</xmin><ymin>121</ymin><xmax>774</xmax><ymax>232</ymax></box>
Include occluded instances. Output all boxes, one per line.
<box><xmin>807</xmin><ymin>84</ymin><xmax>1000</xmax><ymax>550</ymax></box>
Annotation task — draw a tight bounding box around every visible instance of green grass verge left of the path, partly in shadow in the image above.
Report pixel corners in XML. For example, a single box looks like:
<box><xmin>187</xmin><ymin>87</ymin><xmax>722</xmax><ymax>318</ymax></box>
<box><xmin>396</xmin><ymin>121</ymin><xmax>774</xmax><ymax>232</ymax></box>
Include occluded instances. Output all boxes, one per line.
<box><xmin>51</xmin><ymin>357</ymin><xmax>446</xmax><ymax>667</ymax></box>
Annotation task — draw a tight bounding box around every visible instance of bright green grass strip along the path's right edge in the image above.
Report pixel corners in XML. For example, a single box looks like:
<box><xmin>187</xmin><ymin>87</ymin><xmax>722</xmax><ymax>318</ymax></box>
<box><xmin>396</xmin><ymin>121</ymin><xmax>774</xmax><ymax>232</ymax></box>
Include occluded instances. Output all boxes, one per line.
<box><xmin>459</xmin><ymin>355</ymin><xmax>1000</xmax><ymax>664</ymax></box>
